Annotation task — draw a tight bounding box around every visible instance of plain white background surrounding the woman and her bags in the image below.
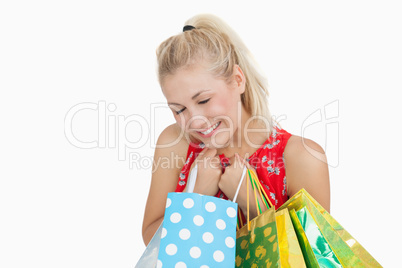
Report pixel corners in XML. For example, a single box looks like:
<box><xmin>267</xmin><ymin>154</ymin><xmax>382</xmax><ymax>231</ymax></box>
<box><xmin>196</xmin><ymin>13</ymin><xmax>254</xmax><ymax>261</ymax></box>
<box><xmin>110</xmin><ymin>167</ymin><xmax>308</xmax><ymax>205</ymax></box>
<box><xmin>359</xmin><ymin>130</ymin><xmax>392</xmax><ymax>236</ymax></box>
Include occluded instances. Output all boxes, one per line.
<box><xmin>0</xmin><ymin>0</ymin><xmax>402</xmax><ymax>267</ymax></box>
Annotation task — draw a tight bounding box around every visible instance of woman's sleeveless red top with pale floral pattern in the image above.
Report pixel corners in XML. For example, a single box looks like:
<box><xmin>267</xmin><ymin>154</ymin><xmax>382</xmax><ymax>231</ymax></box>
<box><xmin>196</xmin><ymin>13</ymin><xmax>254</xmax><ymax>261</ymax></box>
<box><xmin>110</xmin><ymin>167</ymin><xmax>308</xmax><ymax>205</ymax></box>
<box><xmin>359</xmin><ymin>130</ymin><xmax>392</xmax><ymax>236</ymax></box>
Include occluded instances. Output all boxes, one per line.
<box><xmin>175</xmin><ymin>127</ymin><xmax>291</xmax><ymax>208</ymax></box>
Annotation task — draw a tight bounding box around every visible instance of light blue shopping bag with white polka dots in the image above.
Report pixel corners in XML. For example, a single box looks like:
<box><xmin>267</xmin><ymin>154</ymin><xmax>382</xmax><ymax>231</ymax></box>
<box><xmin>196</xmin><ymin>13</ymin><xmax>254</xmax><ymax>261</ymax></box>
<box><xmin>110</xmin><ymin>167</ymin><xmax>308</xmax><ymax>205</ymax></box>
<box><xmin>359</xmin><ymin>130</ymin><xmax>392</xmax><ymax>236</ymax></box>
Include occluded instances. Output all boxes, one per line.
<box><xmin>156</xmin><ymin>193</ymin><xmax>237</xmax><ymax>268</ymax></box>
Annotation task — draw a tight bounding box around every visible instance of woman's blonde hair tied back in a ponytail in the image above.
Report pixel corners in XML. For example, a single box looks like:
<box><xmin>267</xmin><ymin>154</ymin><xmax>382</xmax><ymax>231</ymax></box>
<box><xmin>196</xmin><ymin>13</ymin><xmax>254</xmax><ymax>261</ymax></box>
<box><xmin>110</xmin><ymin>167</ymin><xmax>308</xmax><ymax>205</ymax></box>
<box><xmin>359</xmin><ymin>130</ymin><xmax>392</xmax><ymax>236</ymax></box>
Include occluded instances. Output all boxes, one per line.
<box><xmin>156</xmin><ymin>14</ymin><xmax>272</xmax><ymax>133</ymax></box>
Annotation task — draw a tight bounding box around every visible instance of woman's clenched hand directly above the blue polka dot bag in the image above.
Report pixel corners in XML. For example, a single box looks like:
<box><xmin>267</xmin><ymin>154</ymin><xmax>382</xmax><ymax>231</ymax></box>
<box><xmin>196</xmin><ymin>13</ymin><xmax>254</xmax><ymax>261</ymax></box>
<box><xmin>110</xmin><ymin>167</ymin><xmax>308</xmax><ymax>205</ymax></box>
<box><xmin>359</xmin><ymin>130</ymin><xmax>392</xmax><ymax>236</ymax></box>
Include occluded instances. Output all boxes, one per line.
<box><xmin>190</xmin><ymin>148</ymin><xmax>222</xmax><ymax>196</ymax></box>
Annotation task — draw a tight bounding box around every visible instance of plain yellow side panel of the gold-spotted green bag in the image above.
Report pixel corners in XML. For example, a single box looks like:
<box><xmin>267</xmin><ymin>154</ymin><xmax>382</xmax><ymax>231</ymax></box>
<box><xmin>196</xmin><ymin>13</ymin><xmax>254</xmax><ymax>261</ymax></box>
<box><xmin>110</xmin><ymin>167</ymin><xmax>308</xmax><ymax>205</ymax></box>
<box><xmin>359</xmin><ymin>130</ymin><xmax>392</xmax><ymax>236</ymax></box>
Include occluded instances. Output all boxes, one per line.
<box><xmin>275</xmin><ymin>209</ymin><xmax>306</xmax><ymax>267</ymax></box>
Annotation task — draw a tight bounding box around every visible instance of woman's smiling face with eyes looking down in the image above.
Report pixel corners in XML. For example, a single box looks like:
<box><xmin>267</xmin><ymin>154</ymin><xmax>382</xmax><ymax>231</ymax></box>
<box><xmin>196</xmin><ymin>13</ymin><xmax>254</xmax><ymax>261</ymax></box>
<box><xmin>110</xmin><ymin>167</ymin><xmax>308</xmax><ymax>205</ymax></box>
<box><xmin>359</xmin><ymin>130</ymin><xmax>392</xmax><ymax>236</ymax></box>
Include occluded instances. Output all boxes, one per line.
<box><xmin>162</xmin><ymin>64</ymin><xmax>245</xmax><ymax>148</ymax></box>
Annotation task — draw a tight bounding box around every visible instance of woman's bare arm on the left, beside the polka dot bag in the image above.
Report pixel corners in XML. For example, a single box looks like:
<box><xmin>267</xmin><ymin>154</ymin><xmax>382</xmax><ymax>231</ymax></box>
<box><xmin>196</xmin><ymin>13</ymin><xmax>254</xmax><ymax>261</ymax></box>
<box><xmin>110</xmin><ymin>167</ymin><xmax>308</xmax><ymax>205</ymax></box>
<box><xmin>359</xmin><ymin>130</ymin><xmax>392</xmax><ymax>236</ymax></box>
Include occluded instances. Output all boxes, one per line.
<box><xmin>142</xmin><ymin>125</ymin><xmax>188</xmax><ymax>245</ymax></box>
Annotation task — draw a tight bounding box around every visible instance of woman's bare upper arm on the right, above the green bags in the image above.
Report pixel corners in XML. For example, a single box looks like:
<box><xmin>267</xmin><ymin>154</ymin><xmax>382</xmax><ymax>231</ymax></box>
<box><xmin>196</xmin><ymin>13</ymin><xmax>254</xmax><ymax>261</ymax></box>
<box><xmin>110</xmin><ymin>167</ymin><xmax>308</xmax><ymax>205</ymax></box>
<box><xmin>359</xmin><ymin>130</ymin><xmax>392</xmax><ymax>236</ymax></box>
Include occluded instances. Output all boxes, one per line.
<box><xmin>284</xmin><ymin>136</ymin><xmax>330</xmax><ymax>212</ymax></box>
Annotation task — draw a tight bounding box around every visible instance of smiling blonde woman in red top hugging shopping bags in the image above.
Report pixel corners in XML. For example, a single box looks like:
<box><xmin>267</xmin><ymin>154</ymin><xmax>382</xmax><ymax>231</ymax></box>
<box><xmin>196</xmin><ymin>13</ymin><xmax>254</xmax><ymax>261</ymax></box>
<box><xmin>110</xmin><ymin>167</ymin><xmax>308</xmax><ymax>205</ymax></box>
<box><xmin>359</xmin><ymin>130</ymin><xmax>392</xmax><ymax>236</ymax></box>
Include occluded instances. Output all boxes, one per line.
<box><xmin>143</xmin><ymin>15</ymin><xmax>330</xmax><ymax>245</ymax></box>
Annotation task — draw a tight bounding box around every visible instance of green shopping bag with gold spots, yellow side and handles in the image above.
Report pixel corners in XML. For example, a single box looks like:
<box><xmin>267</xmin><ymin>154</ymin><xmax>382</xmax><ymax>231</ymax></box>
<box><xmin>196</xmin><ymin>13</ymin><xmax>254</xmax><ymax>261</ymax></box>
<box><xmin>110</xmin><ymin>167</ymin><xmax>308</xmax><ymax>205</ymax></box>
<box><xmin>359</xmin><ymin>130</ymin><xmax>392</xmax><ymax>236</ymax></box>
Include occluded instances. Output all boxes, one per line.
<box><xmin>236</xmin><ymin>170</ymin><xmax>308</xmax><ymax>268</ymax></box>
